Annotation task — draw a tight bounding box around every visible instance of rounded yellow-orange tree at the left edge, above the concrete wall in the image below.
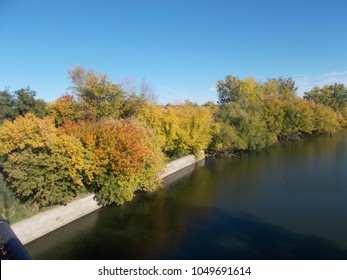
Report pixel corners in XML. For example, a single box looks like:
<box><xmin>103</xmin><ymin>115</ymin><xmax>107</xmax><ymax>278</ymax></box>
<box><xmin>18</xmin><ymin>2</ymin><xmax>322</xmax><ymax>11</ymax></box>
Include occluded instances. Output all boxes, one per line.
<box><xmin>0</xmin><ymin>113</ymin><xmax>91</xmax><ymax>206</ymax></box>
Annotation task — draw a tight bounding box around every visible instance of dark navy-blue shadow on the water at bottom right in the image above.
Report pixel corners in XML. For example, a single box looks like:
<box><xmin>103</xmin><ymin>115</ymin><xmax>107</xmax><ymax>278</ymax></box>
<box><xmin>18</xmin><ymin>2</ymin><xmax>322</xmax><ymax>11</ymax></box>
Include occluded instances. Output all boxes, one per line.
<box><xmin>162</xmin><ymin>209</ymin><xmax>347</xmax><ymax>260</ymax></box>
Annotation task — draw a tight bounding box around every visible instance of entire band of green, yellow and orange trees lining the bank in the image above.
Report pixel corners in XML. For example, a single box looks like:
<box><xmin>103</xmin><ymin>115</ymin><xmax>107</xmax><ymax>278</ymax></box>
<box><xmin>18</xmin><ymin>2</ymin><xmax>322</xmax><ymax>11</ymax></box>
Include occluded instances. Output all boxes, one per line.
<box><xmin>0</xmin><ymin>66</ymin><xmax>347</xmax><ymax>223</ymax></box>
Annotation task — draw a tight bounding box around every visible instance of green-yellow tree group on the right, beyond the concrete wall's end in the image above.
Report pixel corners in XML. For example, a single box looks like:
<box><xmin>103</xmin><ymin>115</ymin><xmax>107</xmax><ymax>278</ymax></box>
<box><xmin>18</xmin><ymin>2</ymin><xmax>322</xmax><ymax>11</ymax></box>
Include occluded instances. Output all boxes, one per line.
<box><xmin>210</xmin><ymin>76</ymin><xmax>347</xmax><ymax>153</ymax></box>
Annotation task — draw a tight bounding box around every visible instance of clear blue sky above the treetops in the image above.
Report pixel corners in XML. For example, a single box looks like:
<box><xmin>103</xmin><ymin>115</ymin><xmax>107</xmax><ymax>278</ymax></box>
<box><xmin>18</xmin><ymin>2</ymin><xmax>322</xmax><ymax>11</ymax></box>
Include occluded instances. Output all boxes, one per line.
<box><xmin>0</xmin><ymin>0</ymin><xmax>347</xmax><ymax>103</ymax></box>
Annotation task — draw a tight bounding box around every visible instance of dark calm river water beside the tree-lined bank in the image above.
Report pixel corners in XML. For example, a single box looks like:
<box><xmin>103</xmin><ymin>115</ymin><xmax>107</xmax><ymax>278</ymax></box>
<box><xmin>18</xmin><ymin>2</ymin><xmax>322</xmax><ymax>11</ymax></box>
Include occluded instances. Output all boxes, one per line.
<box><xmin>26</xmin><ymin>130</ymin><xmax>347</xmax><ymax>260</ymax></box>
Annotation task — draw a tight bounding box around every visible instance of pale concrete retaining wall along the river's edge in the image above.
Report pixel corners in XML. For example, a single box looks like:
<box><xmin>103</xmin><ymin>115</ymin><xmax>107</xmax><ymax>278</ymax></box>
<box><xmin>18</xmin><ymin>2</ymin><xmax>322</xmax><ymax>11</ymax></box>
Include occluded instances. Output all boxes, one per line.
<box><xmin>11</xmin><ymin>154</ymin><xmax>204</xmax><ymax>244</ymax></box>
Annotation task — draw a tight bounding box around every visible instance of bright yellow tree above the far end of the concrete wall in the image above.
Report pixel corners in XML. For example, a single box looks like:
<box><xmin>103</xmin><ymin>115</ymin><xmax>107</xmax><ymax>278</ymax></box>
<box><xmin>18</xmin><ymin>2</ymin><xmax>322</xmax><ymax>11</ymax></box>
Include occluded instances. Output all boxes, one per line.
<box><xmin>139</xmin><ymin>104</ymin><xmax>215</xmax><ymax>158</ymax></box>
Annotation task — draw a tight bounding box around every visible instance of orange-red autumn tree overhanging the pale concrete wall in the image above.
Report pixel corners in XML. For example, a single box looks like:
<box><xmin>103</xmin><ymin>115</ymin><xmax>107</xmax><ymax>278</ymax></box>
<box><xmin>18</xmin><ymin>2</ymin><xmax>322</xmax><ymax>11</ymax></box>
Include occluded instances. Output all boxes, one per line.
<box><xmin>67</xmin><ymin>119</ymin><xmax>163</xmax><ymax>204</ymax></box>
